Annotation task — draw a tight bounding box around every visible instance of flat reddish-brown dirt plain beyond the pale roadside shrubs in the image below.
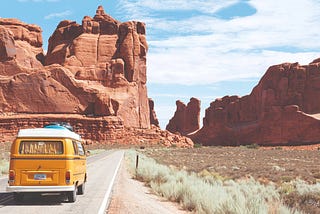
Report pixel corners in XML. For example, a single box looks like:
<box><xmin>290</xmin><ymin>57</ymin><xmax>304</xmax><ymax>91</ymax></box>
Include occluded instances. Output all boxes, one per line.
<box><xmin>140</xmin><ymin>145</ymin><xmax>320</xmax><ymax>183</ymax></box>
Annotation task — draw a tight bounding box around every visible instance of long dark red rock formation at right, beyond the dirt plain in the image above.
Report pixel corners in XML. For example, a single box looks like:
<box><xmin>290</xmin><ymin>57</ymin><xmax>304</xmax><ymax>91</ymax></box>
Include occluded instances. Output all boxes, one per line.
<box><xmin>191</xmin><ymin>60</ymin><xmax>320</xmax><ymax>145</ymax></box>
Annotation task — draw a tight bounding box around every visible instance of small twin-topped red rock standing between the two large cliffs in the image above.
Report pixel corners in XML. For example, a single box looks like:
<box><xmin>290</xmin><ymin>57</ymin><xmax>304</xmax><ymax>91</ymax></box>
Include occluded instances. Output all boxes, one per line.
<box><xmin>166</xmin><ymin>97</ymin><xmax>200</xmax><ymax>135</ymax></box>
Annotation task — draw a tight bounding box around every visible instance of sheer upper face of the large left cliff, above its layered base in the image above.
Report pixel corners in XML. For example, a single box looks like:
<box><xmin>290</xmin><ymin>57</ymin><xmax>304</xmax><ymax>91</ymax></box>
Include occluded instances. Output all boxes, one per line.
<box><xmin>0</xmin><ymin>6</ymin><xmax>150</xmax><ymax>128</ymax></box>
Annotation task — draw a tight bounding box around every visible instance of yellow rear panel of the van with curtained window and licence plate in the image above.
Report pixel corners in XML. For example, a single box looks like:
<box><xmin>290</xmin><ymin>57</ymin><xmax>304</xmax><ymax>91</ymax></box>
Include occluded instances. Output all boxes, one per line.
<box><xmin>12</xmin><ymin>139</ymin><xmax>66</xmax><ymax>186</ymax></box>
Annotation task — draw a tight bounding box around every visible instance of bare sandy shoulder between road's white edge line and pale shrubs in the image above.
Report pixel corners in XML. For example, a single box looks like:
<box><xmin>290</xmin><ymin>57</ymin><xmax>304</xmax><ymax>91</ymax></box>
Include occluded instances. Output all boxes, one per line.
<box><xmin>107</xmin><ymin>162</ymin><xmax>190</xmax><ymax>214</ymax></box>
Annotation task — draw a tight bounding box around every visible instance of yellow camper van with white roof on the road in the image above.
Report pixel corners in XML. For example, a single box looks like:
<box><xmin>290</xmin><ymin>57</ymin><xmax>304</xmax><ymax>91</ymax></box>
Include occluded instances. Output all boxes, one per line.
<box><xmin>7</xmin><ymin>124</ymin><xmax>87</xmax><ymax>202</ymax></box>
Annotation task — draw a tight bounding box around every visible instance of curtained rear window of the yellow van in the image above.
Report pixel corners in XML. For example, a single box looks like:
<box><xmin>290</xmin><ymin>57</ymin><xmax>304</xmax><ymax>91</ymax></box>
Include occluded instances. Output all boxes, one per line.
<box><xmin>19</xmin><ymin>141</ymin><xmax>63</xmax><ymax>155</ymax></box>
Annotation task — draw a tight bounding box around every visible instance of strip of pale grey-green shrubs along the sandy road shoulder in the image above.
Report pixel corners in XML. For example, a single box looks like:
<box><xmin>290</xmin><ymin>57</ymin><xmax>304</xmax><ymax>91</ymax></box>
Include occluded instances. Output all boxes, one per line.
<box><xmin>126</xmin><ymin>151</ymin><xmax>293</xmax><ymax>214</ymax></box>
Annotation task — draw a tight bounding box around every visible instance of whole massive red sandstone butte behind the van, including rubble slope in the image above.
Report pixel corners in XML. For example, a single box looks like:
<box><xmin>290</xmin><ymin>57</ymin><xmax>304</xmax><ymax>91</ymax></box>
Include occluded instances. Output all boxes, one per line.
<box><xmin>0</xmin><ymin>6</ymin><xmax>193</xmax><ymax>147</ymax></box>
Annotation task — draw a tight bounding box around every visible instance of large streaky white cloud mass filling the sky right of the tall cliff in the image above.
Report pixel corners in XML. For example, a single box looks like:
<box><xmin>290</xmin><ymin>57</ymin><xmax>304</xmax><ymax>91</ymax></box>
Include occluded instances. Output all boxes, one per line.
<box><xmin>117</xmin><ymin>0</ymin><xmax>320</xmax><ymax>84</ymax></box>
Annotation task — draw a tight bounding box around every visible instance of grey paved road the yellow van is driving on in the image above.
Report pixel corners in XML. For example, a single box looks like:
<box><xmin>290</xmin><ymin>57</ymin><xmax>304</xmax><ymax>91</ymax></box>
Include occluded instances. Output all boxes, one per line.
<box><xmin>0</xmin><ymin>151</ymin><xmax>123</xmax><ymax>214</ymax></box>
